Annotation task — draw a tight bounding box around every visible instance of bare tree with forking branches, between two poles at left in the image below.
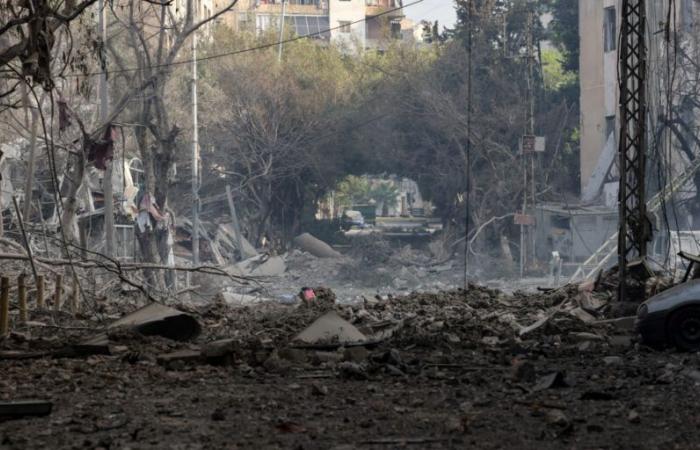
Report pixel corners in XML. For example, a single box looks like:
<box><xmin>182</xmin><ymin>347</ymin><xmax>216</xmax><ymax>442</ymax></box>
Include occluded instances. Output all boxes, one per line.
<box><xmin>98</xmin><ymin>0</ymin><xmax>237</xmax><ymax>288</ymax></box>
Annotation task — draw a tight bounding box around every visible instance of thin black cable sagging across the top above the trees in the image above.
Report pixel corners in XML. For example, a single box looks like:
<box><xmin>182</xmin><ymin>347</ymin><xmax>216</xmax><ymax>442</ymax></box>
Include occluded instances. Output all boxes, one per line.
<box><xmin>64</xmin><ymin>0</ymin><xmax>424</xmax><ymax>77</ymax></box>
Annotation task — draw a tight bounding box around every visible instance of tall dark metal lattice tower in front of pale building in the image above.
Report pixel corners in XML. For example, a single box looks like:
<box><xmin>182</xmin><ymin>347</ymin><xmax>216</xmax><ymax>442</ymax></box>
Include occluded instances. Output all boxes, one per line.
<box><xmin>617</xmin><ymin>0</ymin><xmax>651</xmax><ymax>301</ymax></box>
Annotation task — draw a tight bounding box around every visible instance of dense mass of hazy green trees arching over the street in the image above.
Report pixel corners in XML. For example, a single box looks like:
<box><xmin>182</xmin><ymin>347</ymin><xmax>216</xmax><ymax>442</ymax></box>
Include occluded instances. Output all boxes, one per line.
<box><xmin>181</xmin><ymin>1</ymin><xmax>578</xmax><ymax>244</ymax></box>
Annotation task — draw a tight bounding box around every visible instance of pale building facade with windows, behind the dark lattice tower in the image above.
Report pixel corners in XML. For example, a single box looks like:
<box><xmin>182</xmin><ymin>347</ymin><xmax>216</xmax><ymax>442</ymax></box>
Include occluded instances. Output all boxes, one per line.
<box><xmin>579</xmin><ymin>0</ymin><xmax>700</xmax><ymax>207</ymax></box>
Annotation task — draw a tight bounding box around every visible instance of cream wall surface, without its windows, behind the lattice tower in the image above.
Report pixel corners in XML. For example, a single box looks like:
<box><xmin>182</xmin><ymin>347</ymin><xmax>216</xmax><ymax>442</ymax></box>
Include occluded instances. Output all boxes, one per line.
<box><xmin>579</xmin><ymin>0</ymin><xmax>700</xmax><ymax>207</ymax></box>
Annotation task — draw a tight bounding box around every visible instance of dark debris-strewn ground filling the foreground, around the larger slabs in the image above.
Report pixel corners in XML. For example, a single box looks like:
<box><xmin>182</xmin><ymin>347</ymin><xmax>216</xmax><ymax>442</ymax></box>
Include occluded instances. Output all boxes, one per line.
<box><xmin>0</xmin><ymin>288</ymin><xmax>700</xmax><ymax>449</ymax></box>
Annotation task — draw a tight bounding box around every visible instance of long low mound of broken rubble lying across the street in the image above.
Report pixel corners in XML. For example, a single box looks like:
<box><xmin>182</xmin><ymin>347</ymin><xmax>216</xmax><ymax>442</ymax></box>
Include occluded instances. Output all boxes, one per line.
<box><xmin>0</xmin><ymin>286</ymin><xmax>624</xmax><ymax>380</ymax></box>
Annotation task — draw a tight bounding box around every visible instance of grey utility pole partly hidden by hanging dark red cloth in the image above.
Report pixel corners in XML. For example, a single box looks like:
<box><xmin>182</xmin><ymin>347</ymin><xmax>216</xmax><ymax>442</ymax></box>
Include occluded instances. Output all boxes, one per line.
<box><xmin>97</xmin><ymin>0</ymin><xmax>115</xmax><ymax>258</ymax></box>
